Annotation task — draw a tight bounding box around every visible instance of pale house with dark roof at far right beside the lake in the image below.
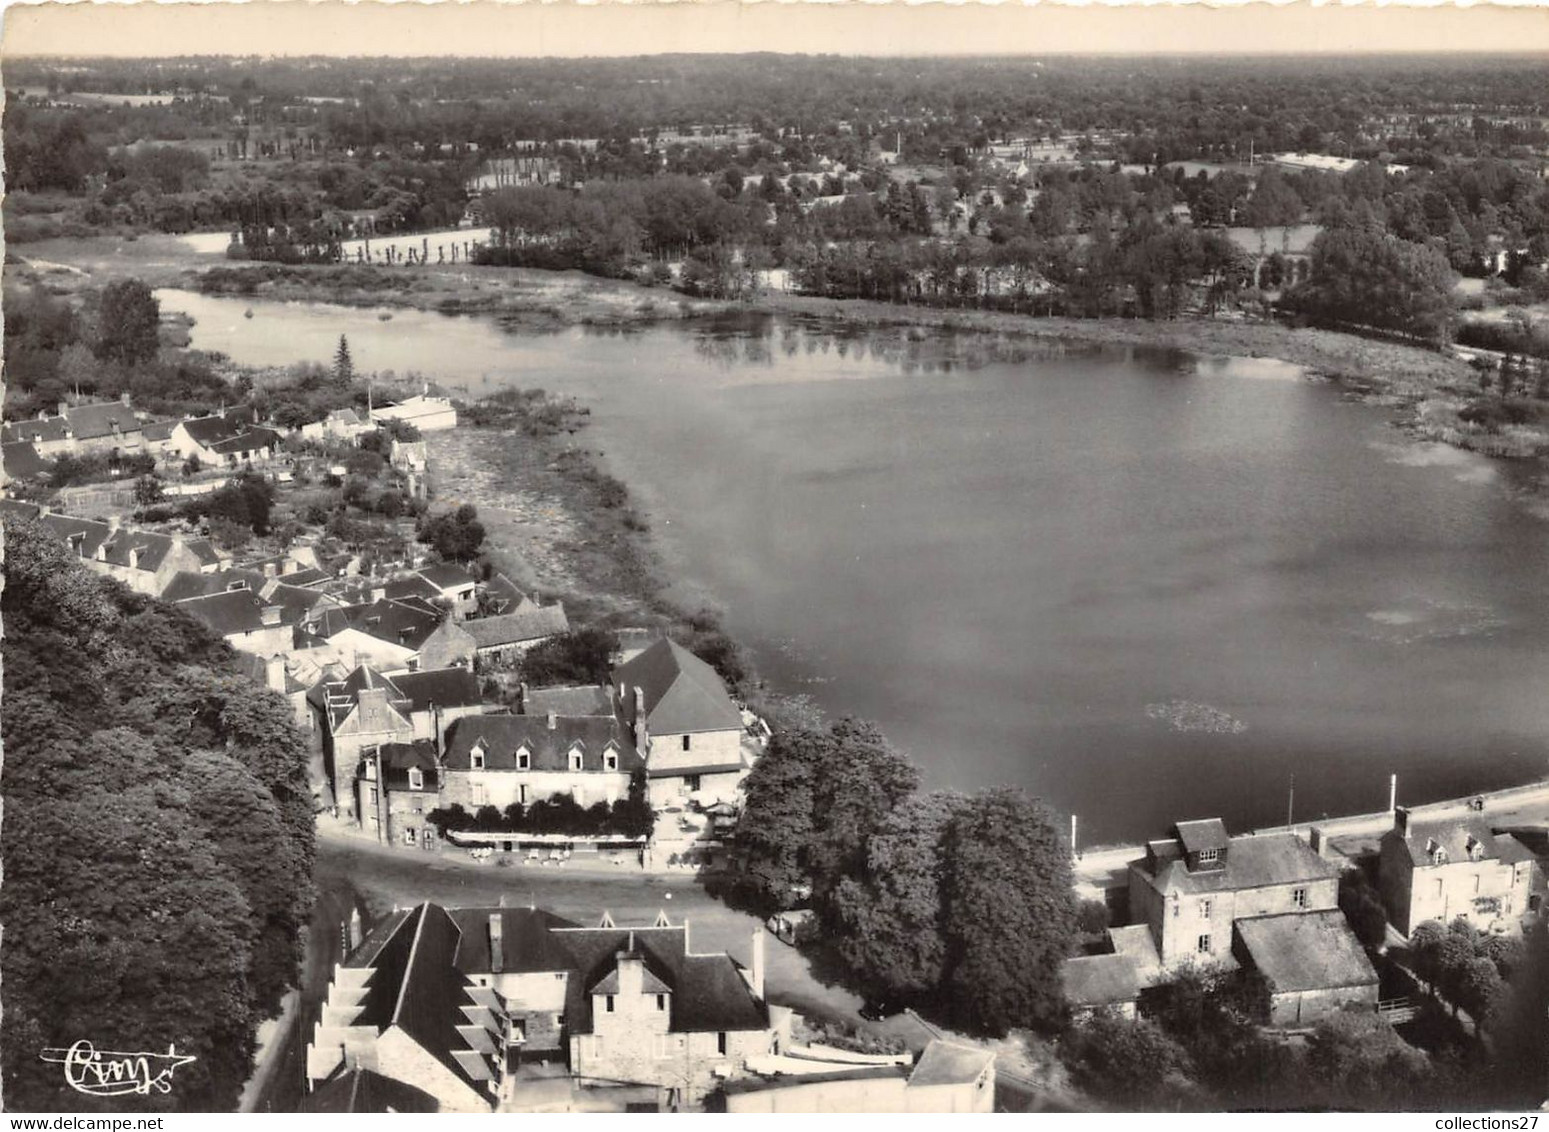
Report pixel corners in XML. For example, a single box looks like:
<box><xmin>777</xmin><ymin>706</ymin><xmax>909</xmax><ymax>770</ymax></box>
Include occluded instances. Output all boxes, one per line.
<box><xmin>1377</xmin><ymin>807</ymin><xmax>1541</xmax><ymax>935</ymax></box>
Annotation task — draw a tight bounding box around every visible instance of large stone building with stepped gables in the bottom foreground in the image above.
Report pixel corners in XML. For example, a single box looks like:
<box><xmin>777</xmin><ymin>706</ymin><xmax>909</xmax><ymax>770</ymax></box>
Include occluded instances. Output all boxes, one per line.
<box><xmin>307</xmin><ymin>904</ymin><xmax>790</xmax><ymax>1112</ymax></box>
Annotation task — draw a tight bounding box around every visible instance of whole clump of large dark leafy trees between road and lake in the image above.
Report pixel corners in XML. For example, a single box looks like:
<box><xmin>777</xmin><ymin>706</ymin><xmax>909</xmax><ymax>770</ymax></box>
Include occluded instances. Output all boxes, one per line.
<box><xmin>723</xmin><ymin>719</ymin><xmax>1075</xmax><ymax>1034</ymax></box>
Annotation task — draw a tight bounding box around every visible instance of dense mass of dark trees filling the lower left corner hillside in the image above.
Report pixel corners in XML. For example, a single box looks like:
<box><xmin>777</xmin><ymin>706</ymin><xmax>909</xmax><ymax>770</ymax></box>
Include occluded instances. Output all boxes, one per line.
<box><xmin>0</xmin><ymin>519</ymin><xmax>313</xmax><ymax>1112</ymax></box>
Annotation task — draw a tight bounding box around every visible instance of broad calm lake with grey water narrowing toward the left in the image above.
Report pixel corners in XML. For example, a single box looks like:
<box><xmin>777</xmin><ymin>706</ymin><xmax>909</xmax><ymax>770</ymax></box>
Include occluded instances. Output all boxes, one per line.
<box><xmin>161</xmin><ymin>291</ymin><xmax>1549</xmax><ymax>842</ymax></box>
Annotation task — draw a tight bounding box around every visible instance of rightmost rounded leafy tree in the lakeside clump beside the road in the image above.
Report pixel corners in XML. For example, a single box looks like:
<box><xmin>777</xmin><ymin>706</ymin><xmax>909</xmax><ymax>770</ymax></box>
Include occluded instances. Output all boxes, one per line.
<box><xmin>942</xmin><ymin>787</ymin><xmax>1075</xmax><ymax>1034</ymax></box>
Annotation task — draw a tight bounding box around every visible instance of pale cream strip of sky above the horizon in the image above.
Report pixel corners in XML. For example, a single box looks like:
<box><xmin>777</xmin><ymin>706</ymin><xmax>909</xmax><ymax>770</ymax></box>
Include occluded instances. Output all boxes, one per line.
<box><xmin>0</xmin><ymin>0</ymin><xmax>1549</xmax><ymax>57</ymax></box>
